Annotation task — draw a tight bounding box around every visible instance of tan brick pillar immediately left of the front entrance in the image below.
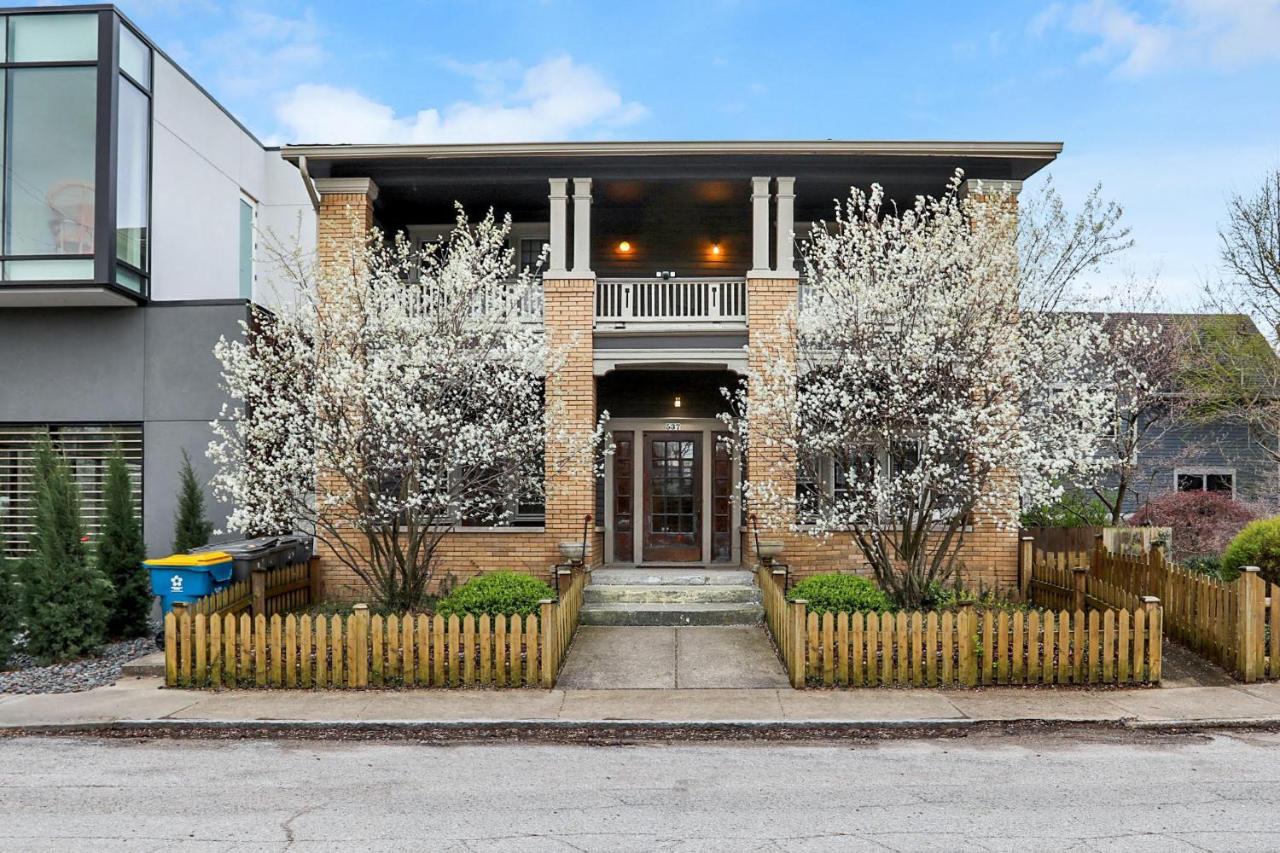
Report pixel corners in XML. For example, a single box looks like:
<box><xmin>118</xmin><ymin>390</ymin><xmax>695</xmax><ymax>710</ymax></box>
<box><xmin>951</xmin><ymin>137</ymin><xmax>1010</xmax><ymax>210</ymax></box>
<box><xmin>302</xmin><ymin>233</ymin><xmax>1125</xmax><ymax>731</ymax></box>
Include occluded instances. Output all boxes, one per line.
<box><xmin>543</xmin><ymin>277</ymin><xmax>603</xmax><ymax>565</ymax></box>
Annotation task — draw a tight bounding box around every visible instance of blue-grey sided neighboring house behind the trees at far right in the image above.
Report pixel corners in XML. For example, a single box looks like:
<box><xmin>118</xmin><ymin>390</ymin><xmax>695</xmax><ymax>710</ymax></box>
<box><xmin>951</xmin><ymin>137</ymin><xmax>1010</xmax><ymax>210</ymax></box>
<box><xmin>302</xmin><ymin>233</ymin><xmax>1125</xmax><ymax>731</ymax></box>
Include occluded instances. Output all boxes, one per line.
<box><xmin>1100</xmin><ymin>314</ymin><xmax>1280</xmax><ymax>514</ymax></box>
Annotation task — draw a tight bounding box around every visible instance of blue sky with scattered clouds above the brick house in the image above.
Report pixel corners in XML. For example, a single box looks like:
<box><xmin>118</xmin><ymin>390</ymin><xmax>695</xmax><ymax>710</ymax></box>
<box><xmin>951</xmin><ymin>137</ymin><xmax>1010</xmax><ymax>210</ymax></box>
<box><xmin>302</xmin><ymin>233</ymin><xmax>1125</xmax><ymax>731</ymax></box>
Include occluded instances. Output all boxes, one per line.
<box><xmin>37</xmin><ymin>0</ymin><xmax>1280</xmax><ymax>306</ymax></box>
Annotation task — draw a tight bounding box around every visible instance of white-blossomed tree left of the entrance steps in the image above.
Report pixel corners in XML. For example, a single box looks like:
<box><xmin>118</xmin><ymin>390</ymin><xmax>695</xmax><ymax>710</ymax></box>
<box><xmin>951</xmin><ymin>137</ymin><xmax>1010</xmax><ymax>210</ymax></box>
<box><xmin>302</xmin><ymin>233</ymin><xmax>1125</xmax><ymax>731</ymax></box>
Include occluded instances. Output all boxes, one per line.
<box><xmin>209</xmin><ymin>206</ymin><xmax>600</xmax><ymax>610</ymax></box>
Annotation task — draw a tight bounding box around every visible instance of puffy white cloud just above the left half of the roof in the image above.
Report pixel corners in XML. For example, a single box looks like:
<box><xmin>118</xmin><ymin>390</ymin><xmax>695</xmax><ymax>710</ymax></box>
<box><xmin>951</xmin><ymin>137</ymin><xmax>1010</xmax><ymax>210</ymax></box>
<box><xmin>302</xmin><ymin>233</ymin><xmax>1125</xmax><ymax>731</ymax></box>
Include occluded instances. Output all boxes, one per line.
<box><xmin>275</xmin><ymin>56</ymin><xmax>645</xmax><ymax>142</ymax></box>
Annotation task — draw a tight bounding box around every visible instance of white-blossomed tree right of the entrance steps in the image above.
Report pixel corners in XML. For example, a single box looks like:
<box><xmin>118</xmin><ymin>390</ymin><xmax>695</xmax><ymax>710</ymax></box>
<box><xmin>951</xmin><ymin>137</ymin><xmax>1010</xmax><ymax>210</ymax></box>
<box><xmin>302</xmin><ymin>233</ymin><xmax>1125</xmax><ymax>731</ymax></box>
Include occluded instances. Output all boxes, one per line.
<box><xmin>735</xmin><ymin>173</ymin><xmax>1114</xmax><ymax>607</ymax></box>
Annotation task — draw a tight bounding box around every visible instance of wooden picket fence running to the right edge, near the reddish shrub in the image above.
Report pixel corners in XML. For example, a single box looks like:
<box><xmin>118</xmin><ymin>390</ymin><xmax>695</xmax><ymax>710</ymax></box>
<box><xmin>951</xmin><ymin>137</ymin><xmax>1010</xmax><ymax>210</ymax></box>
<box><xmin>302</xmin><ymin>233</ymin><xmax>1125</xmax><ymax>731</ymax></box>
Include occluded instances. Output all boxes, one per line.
<box><xmin>1049</xmin><ymin>540</ymin><xmax>1280</xmax><ymax>681</ymax></box>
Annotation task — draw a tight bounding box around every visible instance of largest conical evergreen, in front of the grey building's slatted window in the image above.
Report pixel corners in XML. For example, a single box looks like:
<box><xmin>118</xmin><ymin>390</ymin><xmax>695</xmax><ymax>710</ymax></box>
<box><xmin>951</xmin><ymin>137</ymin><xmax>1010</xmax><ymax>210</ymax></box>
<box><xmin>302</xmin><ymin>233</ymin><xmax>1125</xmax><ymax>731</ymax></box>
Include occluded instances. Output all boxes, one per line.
<box><xmin>22</xmin><ymin>438</ymin><xmax>113</xmax><ymax>663</ymax></box>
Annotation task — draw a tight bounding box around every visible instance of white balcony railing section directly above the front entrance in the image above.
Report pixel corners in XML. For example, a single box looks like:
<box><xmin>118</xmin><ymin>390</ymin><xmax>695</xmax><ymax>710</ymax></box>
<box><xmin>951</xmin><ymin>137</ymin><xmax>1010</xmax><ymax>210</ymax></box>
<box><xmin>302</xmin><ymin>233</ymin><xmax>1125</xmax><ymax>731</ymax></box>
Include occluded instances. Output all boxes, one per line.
<box><xmin>595</xmin><ymin>278</ymin><xmax>746</xmax><ymax>325</ymax></box>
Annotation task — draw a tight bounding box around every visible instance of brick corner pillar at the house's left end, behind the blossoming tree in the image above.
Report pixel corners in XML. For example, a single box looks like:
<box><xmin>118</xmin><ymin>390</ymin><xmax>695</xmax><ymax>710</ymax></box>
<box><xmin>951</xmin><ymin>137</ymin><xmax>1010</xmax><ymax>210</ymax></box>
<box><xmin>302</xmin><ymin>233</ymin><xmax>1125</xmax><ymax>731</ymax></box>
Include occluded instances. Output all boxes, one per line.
<box><xmin>315</xmin><ymin>178</ymin><xmax>378</xmax><ymax>599</ymax></box>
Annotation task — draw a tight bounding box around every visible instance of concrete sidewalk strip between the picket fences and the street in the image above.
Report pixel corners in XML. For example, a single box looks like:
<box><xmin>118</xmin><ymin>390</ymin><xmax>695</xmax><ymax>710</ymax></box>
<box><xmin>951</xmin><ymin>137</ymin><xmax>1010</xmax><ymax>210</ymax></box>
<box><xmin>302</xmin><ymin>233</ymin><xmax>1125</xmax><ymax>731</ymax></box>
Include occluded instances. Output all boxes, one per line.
<box><xmin>0</xmin><ymin>678</ymin><xmax>1280</xmax><ymax>729</ymax></box>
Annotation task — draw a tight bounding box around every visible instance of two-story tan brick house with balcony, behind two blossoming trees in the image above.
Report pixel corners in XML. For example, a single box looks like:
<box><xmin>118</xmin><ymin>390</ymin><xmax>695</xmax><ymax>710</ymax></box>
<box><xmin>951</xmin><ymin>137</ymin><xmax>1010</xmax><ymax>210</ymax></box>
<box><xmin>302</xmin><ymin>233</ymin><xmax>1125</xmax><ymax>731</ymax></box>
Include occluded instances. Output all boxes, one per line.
<box><xmin>283</xmin><ymin>141</ymin><xmax>1061</xmax><ymax>594</ymax></box>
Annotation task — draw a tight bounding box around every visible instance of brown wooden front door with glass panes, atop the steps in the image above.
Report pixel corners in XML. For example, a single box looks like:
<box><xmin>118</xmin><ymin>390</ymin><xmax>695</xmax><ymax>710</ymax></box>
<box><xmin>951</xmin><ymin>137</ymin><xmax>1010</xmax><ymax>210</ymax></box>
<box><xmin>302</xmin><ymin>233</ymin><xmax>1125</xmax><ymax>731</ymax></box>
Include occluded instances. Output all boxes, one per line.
<box><xmin>643</xmin><ymin>432</ymin><xmax>703</xmax><ymax>562</ymax></box>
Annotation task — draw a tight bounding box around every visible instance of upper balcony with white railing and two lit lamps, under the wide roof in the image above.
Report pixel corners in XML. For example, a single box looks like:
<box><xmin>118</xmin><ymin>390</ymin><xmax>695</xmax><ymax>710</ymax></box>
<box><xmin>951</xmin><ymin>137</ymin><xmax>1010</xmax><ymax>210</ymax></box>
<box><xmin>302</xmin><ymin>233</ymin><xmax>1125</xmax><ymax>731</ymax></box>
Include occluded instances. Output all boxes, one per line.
<box><xmin>293</xmin><ymin>141</ymin><xmax>1061</xmax><ymax>335</ymax></box>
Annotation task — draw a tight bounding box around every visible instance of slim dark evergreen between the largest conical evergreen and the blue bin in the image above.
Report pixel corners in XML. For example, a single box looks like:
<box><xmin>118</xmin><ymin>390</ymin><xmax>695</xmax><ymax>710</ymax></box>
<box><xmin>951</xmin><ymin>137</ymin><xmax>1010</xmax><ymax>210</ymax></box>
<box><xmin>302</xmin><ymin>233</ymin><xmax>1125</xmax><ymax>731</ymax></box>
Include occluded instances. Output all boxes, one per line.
<box><xmin>97</xmin><ymin>447</ymin><xmax>152</xmax><ymax>638</ymax></box>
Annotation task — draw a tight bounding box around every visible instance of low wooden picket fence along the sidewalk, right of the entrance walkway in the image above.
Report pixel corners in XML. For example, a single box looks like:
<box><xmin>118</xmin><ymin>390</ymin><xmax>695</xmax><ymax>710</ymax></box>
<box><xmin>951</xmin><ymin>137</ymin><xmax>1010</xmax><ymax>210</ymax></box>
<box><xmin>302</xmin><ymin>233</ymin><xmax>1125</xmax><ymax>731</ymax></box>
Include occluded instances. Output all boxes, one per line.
<box><xmin>758</xmin><ymin>569</ymin><xmax>1162</xmax><ymax>688</ymax></box>
